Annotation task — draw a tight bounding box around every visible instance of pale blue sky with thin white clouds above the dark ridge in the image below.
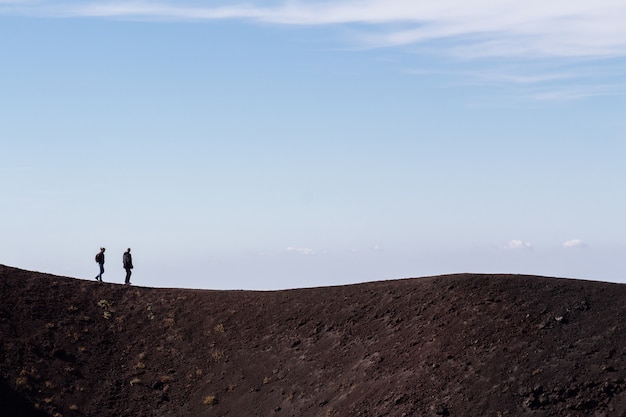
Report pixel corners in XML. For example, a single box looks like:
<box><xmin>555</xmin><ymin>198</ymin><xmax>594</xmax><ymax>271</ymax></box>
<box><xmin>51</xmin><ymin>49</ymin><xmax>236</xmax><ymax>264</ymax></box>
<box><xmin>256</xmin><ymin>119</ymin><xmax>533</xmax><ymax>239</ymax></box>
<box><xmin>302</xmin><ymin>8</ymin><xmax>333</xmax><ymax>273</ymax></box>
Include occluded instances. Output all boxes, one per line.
<box><xmin>0</xmin><ymin>0</ymin><xmax>626</xmax><ymax>290</ymax></box>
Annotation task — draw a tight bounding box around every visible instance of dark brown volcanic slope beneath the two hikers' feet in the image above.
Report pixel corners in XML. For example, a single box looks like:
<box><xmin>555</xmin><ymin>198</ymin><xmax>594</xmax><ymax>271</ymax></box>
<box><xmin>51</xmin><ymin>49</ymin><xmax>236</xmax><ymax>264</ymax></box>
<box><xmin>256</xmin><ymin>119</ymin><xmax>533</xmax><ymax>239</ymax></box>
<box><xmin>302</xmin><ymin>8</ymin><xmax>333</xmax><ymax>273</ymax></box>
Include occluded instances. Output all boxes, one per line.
<box><xmin>0</xmin><ymin>266</ymin><xmax>626</xmax><ymax>417</ymax></box>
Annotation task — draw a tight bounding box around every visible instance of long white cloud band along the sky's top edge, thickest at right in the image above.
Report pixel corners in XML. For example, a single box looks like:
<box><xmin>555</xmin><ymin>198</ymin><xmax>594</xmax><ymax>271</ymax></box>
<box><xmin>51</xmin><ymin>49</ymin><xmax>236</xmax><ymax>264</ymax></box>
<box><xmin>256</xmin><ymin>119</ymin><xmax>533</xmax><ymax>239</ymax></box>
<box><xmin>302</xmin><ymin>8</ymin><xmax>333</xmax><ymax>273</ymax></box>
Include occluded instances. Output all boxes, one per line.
<box><xmin>0</xmin><ymin>0</ymin><xmax>626</xmax><ymax>58</ymax></box>
